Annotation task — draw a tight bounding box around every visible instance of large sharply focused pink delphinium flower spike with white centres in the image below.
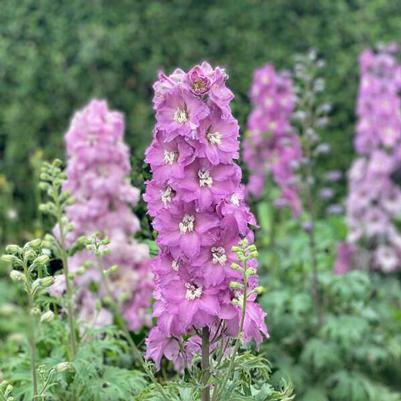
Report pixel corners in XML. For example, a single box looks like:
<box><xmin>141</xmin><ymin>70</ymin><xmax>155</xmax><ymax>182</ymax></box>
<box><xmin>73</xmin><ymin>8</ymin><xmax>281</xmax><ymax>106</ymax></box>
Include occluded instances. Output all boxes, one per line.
<box><xmin>145</xmin><ymin>62</ymin><xmax>267</xmax><ymax>369</ymax></box>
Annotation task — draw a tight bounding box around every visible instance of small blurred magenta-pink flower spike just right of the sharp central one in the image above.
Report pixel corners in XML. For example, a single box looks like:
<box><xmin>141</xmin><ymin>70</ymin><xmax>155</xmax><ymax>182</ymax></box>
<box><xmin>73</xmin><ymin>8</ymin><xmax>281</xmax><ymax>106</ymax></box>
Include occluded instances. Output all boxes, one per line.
<box><xmin>244</xmin><ymin>64</ymin><xmax>302</xmax><ymax>215</ymax></box>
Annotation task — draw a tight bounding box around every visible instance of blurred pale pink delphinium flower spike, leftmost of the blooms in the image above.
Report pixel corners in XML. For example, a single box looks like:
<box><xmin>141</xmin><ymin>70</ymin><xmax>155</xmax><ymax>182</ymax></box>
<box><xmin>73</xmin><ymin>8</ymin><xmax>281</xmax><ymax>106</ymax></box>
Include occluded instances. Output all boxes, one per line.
<box><xmin>63</xmin><ymin>100</ymin><xmax>153</xmax><ymax>330</ymax></box>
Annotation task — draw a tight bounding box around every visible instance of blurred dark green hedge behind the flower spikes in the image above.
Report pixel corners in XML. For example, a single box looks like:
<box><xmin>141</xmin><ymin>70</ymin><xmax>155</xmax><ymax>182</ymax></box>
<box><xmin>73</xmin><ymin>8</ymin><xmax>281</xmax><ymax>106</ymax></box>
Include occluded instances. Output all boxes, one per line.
<box><xmin>0</xmin><ymin>0</ymin><xmax>401</xmax><ymax>235</ymax></box>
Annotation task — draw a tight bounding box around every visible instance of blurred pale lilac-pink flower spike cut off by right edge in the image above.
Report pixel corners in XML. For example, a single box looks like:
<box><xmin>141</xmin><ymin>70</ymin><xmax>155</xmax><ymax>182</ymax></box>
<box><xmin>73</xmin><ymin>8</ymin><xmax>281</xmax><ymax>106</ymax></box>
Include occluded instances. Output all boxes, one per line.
<box><xmin>347</xmin><ymin>45</ymin><xmax>401</xmax><ymax>272</ymax></box>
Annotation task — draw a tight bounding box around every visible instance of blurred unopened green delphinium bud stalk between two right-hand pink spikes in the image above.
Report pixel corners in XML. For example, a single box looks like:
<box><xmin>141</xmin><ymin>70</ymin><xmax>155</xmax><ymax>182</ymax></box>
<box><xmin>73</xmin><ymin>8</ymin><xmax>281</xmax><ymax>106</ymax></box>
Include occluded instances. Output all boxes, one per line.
<box><xmin>294</xmin><ymin>49</ymin><xmax>330</xmax><ymax>325</ymax></box>
